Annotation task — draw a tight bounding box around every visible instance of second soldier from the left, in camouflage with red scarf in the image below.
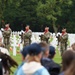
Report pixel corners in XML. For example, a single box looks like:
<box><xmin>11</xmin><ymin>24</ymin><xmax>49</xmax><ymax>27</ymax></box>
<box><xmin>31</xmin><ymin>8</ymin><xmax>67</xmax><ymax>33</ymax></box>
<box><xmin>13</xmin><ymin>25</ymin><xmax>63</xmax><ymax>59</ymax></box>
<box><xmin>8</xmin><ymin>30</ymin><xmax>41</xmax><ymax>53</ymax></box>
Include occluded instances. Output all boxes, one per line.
<box><xmin>23</xmin><ymin>25</ymin><xmax>32</xmax><ymax>46</ymax></box>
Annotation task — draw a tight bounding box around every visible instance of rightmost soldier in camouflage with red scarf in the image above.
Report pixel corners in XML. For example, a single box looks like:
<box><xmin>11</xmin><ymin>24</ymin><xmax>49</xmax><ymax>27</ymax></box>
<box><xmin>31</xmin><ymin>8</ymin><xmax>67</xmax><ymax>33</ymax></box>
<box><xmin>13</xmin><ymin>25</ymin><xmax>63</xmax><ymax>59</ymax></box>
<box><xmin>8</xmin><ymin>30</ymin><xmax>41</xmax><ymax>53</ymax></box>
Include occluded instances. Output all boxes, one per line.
<box><xmin>60</xmin><ymin>29</ymin><xmax>68</xmax><ymax>56</ymax></box>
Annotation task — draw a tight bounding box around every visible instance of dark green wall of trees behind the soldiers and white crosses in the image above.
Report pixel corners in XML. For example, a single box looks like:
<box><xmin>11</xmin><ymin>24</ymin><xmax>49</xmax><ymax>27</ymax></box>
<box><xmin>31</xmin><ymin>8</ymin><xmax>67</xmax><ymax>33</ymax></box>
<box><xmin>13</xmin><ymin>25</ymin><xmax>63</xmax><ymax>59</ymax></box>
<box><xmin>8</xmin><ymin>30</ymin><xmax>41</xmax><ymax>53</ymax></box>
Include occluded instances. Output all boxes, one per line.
<box><xmin>0</xmin><ymin>0</ymin><xmax>75</xmax><ymax>32</ymax></box>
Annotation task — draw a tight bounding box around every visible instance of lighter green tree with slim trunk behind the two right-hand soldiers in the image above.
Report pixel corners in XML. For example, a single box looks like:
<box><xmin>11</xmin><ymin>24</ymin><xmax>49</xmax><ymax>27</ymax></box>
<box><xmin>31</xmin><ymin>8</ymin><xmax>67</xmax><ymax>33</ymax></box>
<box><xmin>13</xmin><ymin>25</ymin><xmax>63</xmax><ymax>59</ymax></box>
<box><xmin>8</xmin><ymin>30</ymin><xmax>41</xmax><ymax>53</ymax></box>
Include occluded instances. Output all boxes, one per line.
<box><xmin>37</xmin><ymin>0</ymin><xmax>62</xmax><ymax>33</ymax></box>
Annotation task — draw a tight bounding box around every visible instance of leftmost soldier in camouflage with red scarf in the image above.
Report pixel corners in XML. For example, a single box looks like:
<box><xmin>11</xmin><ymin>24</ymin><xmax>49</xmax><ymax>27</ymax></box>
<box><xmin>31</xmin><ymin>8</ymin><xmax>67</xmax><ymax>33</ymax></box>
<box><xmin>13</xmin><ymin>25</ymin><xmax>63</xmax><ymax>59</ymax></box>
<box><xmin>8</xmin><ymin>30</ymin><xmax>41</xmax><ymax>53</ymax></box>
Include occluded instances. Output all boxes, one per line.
<box><xmin>3</xmin><ymin>24</ymin><xmax>11</xmax><ymax>50</ymax></box>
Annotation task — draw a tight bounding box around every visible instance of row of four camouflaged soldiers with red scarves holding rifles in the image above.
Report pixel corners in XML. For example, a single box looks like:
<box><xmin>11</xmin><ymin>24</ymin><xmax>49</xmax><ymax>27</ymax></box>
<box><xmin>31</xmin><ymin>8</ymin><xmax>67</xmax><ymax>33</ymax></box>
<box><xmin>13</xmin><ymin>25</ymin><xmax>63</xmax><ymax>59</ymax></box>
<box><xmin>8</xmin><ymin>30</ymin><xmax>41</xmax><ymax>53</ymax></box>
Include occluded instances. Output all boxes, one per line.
<box><xmin>2</xmin><ymin>24</ymin><xmax>68</xmax><ymax>55</ymax></box>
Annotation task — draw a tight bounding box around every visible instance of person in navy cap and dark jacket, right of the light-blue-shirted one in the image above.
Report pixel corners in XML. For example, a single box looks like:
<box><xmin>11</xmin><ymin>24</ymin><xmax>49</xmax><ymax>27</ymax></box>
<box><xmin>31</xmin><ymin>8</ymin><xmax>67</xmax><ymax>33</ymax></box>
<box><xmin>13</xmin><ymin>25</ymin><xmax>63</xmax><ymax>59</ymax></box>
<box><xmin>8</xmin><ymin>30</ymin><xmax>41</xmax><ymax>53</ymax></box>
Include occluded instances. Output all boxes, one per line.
<box><xmin>41</xmin><ymin>46</ymin><xmax>61</xmax><ymax>75</ymax></box>
